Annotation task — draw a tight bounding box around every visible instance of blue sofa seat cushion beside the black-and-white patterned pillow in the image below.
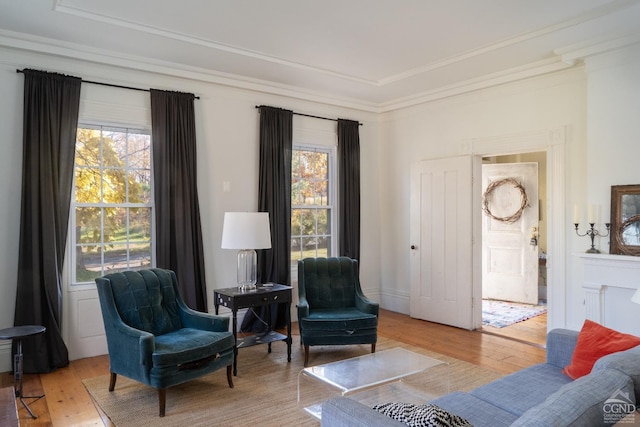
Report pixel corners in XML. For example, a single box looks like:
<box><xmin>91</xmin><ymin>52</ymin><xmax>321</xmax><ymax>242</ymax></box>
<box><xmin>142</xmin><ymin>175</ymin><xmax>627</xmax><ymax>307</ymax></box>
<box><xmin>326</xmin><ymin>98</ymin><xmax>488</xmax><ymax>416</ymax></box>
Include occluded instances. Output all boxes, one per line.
<box><xmin>429</xmin><ymin>391</ymin><xmax>518</xmax><ymax>427</ymax></box>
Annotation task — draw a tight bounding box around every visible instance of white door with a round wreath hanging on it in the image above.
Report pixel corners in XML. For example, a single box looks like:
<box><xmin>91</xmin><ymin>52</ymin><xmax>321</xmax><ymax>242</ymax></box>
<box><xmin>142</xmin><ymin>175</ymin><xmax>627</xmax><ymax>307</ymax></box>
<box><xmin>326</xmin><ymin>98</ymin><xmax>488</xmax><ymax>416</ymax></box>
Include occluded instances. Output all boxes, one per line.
<box><xmin>482</xmin><ymin>163</ymin><xmax>538</xmax><ymax>304</ymax></box>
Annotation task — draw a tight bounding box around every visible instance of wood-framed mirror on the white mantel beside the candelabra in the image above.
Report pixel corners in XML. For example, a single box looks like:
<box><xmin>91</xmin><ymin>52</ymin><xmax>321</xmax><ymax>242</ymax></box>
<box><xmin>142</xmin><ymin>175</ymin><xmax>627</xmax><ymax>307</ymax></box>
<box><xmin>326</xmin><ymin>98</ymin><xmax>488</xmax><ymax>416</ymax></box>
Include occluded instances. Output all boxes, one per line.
<box><xmin>610</xmin><ymin>185</ymin><xmax>640</xmax><ymax>256</ymax></box>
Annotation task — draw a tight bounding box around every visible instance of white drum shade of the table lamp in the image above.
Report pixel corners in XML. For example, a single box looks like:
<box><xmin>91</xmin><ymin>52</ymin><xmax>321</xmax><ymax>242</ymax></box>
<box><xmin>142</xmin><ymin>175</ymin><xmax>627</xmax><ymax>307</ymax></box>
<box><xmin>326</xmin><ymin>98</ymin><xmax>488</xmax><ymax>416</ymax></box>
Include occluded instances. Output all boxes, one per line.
<box><xmin>222</xmin><ymin>212</ymin><xmax>271</xmax><ymax>249</ymax></box>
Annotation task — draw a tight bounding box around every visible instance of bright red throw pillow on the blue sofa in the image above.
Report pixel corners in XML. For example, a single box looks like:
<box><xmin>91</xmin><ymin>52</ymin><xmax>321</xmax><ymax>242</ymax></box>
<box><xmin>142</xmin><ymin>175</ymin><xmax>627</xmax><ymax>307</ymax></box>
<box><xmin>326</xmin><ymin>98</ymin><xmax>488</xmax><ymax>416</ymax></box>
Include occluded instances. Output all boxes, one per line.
<box><xmin>562</xmin><ymin>319</ymin><xmax>640</xmax><ymax>380</ymax></box>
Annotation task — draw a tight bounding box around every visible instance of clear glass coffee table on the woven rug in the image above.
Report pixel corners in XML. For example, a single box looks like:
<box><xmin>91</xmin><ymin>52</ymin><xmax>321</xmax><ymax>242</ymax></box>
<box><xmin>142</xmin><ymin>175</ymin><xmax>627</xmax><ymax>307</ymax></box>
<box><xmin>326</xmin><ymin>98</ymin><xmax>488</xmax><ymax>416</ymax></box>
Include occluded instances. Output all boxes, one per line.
<box><xmin>298</xmin><ymin>347</ymin><xmax>449</xmax><ymax>419</ymax></box>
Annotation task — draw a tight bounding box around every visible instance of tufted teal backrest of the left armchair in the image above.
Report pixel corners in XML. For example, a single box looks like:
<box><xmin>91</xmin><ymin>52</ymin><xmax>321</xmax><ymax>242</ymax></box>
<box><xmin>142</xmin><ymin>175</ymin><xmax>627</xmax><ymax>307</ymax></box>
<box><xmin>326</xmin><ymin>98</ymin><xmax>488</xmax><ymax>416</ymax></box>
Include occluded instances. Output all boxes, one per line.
<box><xmin>98</xmin><ymin>268</ymin><xmax>182</xmax><ymax>336</ymax></box>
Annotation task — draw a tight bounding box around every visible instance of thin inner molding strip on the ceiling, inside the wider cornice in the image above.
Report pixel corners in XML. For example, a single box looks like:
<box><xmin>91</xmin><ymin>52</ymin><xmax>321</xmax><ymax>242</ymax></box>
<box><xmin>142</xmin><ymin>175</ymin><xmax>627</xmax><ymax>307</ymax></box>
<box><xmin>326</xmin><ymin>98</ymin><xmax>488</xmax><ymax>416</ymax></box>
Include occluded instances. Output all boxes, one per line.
<box><xmin>53</xmin><ymin>0</ymin><xmax>638</xmax><ymax>87</ymax></box>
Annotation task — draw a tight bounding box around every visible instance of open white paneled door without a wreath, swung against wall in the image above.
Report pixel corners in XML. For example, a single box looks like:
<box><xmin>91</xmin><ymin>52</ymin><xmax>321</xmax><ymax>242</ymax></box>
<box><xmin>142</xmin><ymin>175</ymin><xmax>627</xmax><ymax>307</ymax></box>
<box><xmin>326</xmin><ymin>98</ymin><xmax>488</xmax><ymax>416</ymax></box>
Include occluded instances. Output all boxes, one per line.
<box><xmin>408</xmin><ymin>156</ymin><xmax>480</xmax><ymax>329</ymax></box>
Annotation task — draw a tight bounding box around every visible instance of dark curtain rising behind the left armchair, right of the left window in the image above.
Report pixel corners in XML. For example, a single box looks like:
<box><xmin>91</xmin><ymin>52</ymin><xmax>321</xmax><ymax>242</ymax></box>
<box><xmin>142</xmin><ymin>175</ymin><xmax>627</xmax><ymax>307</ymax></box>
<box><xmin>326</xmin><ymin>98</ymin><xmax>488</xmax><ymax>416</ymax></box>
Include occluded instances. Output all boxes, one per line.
<box><xmin>151</xmin><ymin>89</ymin><xmax>207</xmax><ymax>311</ymax></box>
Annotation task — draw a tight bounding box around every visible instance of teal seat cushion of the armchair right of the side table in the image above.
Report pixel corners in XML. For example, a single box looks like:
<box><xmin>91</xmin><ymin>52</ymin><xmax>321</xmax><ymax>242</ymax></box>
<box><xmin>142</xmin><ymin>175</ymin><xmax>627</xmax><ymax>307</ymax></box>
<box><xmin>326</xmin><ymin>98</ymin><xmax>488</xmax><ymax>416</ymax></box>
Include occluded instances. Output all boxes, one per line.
<box><xmin>300</xmin><ymin>307</ymin><xmax>378</xmax><ymax>332</ymax></box>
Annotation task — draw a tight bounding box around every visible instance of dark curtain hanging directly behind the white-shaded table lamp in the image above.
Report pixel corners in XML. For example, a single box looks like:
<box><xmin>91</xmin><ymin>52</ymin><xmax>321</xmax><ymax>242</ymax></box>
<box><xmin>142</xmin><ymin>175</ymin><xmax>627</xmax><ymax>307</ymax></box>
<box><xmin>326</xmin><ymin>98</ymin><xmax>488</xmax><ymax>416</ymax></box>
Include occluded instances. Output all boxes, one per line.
<box><xmin>241</xmin><ymin>106</ymin><xmax>293</xmax><ymax>332</ymax></box>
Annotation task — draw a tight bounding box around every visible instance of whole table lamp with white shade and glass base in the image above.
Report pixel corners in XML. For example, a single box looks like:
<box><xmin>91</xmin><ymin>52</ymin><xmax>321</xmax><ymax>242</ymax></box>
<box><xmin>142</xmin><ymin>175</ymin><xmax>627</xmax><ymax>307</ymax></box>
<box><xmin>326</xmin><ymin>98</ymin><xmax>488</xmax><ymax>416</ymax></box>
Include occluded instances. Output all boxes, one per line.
<box><xmin>222</xmin><ymin>212</ymin><xmax>271</xmax><ymax>291</ymax></box>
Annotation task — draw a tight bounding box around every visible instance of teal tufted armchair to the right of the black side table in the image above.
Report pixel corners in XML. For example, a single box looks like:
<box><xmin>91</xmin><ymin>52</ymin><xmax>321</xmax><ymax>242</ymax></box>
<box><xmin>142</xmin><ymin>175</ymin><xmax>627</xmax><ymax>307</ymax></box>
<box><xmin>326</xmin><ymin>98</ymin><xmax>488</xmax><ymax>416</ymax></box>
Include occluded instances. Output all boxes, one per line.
<box><xmin>298</xmin><ymin>257</ymin><xmax>379</xmax><ymax>366</ymax></box>
